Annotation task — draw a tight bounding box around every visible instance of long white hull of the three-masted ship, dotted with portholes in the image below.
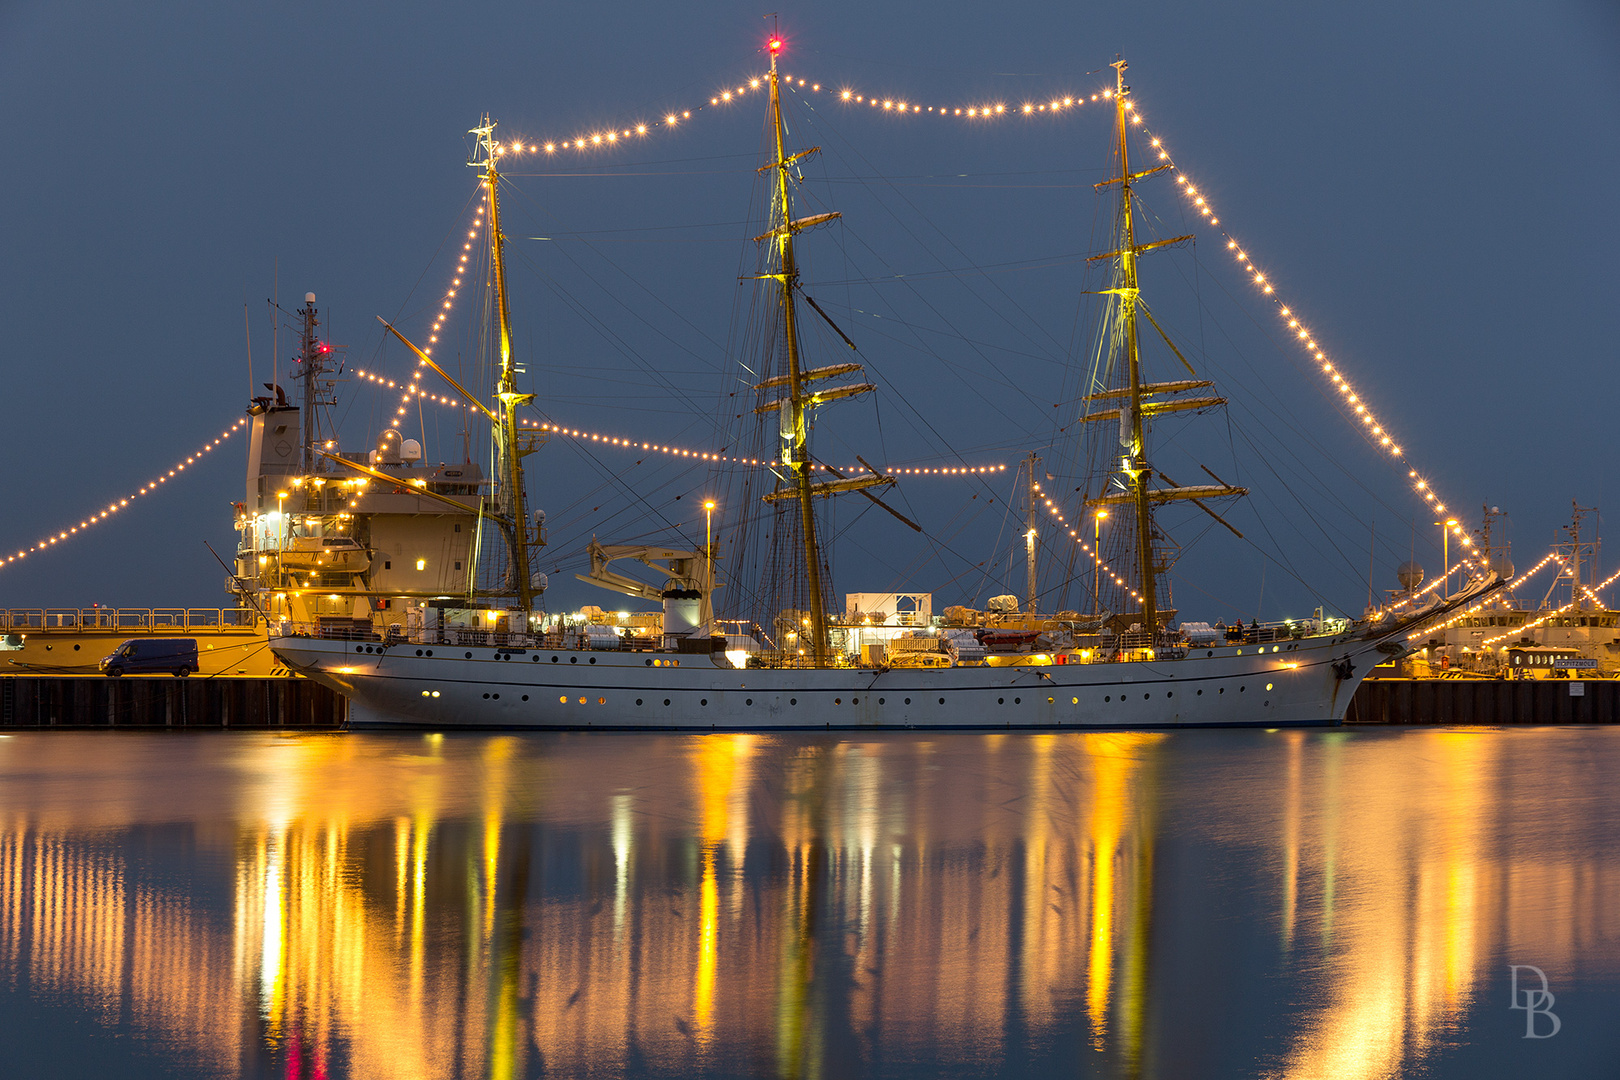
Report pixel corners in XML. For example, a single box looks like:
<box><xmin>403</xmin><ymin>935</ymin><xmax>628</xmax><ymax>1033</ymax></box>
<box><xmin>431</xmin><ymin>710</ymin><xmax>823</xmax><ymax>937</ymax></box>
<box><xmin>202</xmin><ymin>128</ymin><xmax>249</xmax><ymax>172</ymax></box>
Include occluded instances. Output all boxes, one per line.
<box><xmin>272</xmin><ymin>633</ymin><xmax>1388</xmax><ymax>730</ymax></box>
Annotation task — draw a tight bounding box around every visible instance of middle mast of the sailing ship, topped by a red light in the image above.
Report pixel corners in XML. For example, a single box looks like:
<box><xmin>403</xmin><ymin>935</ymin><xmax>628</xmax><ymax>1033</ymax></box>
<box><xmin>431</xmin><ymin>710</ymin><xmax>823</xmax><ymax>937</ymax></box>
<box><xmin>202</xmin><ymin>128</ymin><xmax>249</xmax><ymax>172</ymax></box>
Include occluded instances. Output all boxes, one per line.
<box><xmin>757</xmin><ymin>37</ymin><xmax>894</xmax><ymax>667</ymax></box>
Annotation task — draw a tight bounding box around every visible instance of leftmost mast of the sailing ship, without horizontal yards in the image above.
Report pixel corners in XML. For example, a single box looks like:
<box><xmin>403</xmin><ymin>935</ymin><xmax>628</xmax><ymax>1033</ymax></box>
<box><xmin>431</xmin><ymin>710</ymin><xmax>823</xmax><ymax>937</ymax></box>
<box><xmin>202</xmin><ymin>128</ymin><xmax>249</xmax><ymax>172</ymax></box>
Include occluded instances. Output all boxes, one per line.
<box><xmin>467</xmin><ymin>117</ymin><xmax>535</xmax><ymax>623</ymax></box>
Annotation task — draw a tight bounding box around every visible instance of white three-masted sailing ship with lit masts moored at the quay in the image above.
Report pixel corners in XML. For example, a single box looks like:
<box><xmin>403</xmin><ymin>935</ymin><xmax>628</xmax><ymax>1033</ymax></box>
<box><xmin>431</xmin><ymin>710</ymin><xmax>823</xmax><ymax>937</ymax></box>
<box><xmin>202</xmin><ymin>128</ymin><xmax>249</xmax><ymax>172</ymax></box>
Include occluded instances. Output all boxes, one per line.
<box><xmin>262</xmin><ymin>48</ymin><xmax>1497</xmax><ymax>729</ymax></box>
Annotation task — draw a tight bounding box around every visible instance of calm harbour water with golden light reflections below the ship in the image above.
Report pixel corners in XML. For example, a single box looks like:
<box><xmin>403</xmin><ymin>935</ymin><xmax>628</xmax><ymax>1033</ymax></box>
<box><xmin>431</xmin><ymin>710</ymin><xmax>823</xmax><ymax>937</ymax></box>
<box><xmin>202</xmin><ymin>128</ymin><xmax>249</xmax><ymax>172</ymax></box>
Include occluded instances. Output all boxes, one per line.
<box><xmin>0</xmin><ymin>730</ymin><xmax>1620</xmax><ymax>1078</ymax></box>
